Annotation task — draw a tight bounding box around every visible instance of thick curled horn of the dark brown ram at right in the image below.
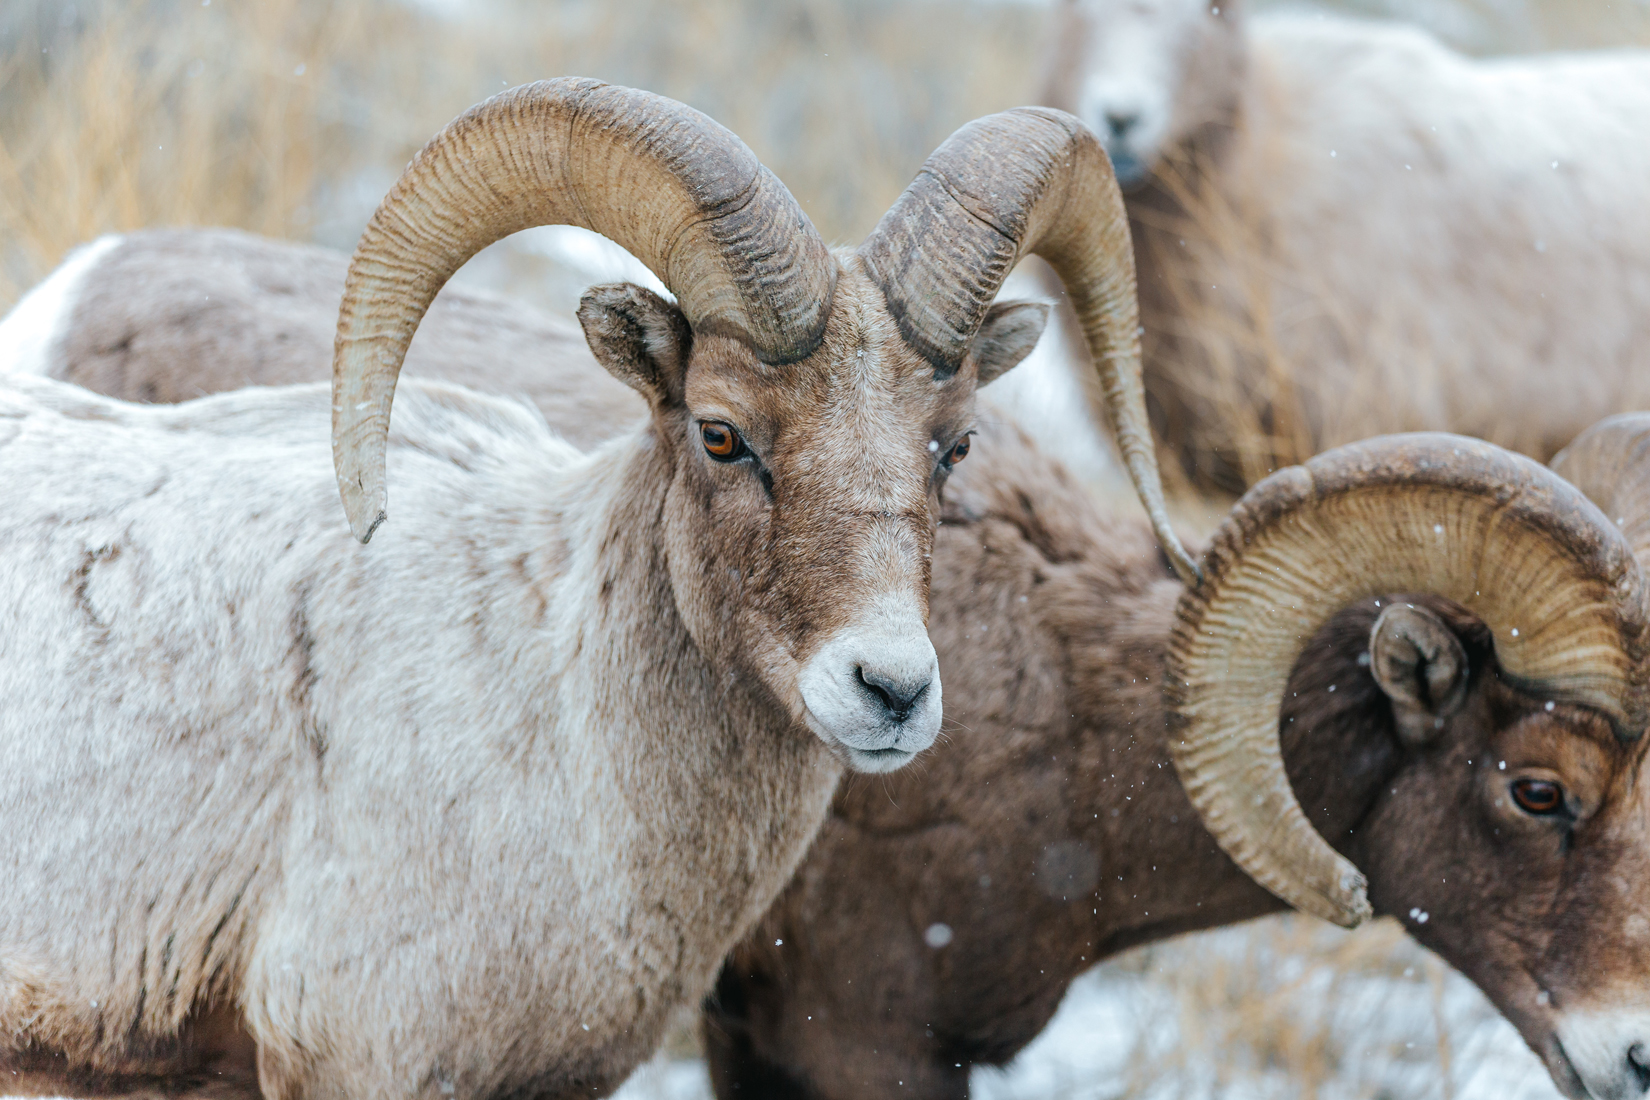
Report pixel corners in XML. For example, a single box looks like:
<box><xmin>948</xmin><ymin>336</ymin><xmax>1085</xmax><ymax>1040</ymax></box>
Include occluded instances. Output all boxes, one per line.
<box><xmin>1167</xmin><ymin>434</ymin><xmax>1647</xmax><ymax>927</ymax></box>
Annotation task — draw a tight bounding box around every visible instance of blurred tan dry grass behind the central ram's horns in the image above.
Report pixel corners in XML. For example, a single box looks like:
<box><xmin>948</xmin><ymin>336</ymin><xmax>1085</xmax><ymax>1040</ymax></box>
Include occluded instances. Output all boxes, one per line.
<box><xmin>0</xmin><ymin>0</ymin><xmax>1041</xmax><ymax>308</ymax></box>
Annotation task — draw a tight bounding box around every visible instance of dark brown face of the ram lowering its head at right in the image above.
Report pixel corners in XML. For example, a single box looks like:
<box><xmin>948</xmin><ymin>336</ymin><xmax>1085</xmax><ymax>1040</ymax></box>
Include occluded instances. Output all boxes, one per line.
<box><xmin>1290</xmin><ymin>597</ymin><xmax>1650</xmax><ymax>1097</ymax></box>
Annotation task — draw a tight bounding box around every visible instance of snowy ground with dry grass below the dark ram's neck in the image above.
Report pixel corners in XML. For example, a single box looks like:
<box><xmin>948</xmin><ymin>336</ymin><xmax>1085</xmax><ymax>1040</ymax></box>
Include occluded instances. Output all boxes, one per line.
<box><xmin>617</xmin><ymin>917</ymin><xmax>1559</xmax><ymax>1100</ymax></box>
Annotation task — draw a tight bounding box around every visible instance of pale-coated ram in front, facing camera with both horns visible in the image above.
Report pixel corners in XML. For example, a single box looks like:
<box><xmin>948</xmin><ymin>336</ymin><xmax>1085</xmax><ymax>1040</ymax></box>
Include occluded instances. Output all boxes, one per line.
<box><xmin>0</xmin><ymin>79</ymin><xmax>1190</xmax><ymax>1097</ymax></box>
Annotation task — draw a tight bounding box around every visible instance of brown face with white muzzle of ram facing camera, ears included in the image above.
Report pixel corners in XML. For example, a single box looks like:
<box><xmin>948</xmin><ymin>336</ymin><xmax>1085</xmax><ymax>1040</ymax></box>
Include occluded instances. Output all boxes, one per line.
<box><xmin>579</xmin><ymin>270</ymin><xmax>1041</xmax><ymax>772</ymax></box>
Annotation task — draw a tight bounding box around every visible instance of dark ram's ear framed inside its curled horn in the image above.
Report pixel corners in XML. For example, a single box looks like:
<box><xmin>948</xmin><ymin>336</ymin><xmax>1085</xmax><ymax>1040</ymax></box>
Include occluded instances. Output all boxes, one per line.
<box><xmin>1370</xmin><ymin>604</ymin><xmax>1467</xmax><ymax>749</ymax></box>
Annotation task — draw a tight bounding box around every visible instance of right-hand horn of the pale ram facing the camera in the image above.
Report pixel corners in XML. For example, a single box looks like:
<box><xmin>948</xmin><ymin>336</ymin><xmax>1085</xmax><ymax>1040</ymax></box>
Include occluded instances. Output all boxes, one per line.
<box><xmin>860</xmin><ymin>107</ymin><xmax>1198</xmax><ymax>584</ymax></box>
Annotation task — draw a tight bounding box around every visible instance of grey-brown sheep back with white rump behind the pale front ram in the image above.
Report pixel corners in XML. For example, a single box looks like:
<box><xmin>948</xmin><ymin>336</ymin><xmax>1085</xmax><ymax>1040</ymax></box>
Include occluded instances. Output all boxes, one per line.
<box><xmin>0</xmin><ymin>229</ymin><xmax>647</xmax><ymax>449</ymax></box>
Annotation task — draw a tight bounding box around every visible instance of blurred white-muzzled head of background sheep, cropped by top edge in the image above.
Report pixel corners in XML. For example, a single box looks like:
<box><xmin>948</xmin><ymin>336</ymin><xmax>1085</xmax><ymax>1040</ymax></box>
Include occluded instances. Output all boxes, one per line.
<box><xmin>1049</xmin><ymin>0</ymin><xmax>1244</xmax><ymax>190</ymax></box>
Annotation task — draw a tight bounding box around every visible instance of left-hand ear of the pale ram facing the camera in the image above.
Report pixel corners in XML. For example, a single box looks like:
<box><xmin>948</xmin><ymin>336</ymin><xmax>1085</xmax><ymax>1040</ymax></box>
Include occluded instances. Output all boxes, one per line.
<box><xmin>579</xmin><ymin>282</ymin><xmax>693</xmax><ymax>406</ymax></box>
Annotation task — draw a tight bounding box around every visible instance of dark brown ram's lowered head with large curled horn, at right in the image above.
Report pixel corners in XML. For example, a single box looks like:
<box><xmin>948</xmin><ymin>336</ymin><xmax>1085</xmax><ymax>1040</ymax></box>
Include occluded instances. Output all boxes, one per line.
<box><xmin>1170</xmin><ymin>417</ymin><xmax>1650</xmax><ymax>1098</ymax></box>
